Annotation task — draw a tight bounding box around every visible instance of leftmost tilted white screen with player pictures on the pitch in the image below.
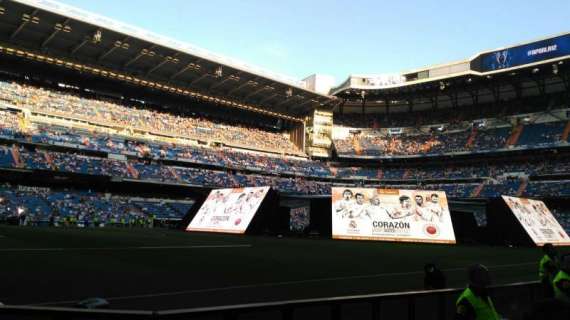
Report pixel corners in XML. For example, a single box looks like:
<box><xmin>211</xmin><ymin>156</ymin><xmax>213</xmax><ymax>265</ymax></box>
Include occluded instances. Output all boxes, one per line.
<box><xmin>186</xmin><ymin>187</ymin><xmax>269</xmax><ymax>233</ymax></box>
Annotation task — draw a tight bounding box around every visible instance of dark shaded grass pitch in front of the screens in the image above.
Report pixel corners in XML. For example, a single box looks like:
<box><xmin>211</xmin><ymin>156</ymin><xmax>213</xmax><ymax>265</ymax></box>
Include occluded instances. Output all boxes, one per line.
<box><xmin>0</xmin><ymin>226</ymin><xmax>560</xmax><ymax>310</ymax></box>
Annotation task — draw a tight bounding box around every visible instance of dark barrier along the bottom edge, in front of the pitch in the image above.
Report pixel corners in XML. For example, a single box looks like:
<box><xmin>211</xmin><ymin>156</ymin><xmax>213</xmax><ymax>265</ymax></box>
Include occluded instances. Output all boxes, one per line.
<box><xmin>0</xmin><ymin>282</ymin><xmax>541</xmax><ymax>320</ymax></box>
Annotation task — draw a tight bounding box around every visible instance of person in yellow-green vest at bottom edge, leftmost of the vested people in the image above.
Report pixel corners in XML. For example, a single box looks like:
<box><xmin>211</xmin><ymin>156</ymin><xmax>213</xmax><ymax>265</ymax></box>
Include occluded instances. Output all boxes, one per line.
<box><xmin>455</xmin><ymin>264</ymin><xmax>501</xmax><ymax>320</ymax></box>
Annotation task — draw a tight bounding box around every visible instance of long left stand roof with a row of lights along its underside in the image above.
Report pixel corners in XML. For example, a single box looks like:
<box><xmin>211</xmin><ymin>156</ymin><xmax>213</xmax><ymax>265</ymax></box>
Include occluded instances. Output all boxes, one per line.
<box><xmin>0</xmin><ymin>0</ymin><xmax>334</xmax><ymax>120</ymax></box>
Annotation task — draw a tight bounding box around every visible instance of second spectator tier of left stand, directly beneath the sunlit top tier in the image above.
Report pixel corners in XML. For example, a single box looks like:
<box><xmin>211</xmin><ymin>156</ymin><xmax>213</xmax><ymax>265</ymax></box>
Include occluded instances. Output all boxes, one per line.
<box><xmin>0</xmin><ymin>110</ymin><xmax>330</xmax><ymax>177</ymax></box>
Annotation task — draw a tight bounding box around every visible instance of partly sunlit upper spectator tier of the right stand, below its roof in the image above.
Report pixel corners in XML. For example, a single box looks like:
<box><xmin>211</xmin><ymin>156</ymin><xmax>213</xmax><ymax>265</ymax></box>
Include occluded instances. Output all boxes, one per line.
<box><xmin>334</xmin><ymin>109</ymin><xmax>569</xmax><ymax>159</ymax></box>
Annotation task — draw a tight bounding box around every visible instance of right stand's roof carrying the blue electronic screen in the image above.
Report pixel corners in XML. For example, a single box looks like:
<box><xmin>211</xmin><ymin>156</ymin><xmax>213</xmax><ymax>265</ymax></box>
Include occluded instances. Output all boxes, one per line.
<box><xmin>331</xmin><ymin>32</ymin><xmax>570</xmax><ymax>112</ymax></box>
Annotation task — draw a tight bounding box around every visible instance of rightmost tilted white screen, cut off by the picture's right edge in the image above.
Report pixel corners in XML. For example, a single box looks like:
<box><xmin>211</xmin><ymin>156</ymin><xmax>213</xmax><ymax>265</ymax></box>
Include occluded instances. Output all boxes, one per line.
<box><xmin>503</xmin><ymin>196</ymin><xmax>570</xmax><ymax>246</ymax></box>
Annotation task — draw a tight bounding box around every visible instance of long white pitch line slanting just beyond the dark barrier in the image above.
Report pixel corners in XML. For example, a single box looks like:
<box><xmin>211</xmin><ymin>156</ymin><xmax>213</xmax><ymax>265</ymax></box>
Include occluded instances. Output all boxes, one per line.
<box><xmin>30</xmin><ymin>262</ymin><xmax>536</xmax><ymax>306</ymax></box>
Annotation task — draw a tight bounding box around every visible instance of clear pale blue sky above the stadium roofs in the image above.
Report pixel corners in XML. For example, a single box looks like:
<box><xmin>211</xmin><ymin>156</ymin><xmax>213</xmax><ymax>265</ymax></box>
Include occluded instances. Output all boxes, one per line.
<box><xmin>56</xmin><ymin>0</ymin><xmax>570</xmax><ymax>83</ymax></box>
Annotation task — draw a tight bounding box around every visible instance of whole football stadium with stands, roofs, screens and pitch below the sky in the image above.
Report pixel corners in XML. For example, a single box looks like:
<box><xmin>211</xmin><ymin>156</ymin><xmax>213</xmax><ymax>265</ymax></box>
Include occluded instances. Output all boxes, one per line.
<box><xmin>0</xmin><ymin>0</ymin><xmax>570</xmax><ymax>320</ymax></box>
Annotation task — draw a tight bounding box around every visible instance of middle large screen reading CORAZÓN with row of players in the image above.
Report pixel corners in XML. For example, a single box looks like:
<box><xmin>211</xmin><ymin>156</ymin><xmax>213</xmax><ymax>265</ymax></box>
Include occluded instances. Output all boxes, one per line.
<box><xmin>332</xmin><ymin>188</ymin><xmax>455</xmax><ymax>243</ymax></box>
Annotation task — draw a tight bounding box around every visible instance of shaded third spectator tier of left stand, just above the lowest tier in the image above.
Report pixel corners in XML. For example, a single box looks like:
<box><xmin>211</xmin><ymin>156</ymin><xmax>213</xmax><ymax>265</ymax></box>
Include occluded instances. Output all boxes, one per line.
<box><xmin>0</xmin><ymin>146</ymin><xmax>330</xmax><ymax>195</ymax></box>
